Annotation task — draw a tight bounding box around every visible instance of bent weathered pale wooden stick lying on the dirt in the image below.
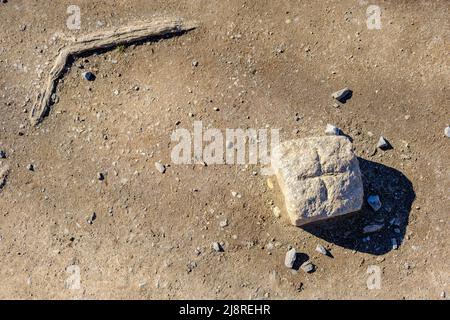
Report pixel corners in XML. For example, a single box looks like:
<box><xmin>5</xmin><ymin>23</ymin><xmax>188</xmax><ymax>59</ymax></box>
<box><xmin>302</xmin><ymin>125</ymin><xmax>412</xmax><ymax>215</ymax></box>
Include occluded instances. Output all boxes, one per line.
<box><xmin>30</xmin><ymin>19</ymin><xmax>196</xmax><ymax>125</ymax></box>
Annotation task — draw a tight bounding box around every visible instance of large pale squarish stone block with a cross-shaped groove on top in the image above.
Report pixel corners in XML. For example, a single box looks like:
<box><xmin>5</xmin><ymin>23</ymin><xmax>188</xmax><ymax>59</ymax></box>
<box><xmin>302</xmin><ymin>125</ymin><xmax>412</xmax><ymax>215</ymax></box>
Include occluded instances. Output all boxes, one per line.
<box><xmin>271</xmin><ymin>136</ymin><xmax>363</xmax><ymax>226</ymax></box>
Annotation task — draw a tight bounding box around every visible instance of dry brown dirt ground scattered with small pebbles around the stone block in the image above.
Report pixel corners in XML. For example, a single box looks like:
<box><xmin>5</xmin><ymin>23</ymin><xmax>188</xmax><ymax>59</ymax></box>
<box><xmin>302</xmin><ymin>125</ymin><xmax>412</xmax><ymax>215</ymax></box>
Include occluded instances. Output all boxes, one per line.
<box><xmin>0</xmin><ymin>0</ymin><xmax>450</xmax><ymax>299</ymax></box>
